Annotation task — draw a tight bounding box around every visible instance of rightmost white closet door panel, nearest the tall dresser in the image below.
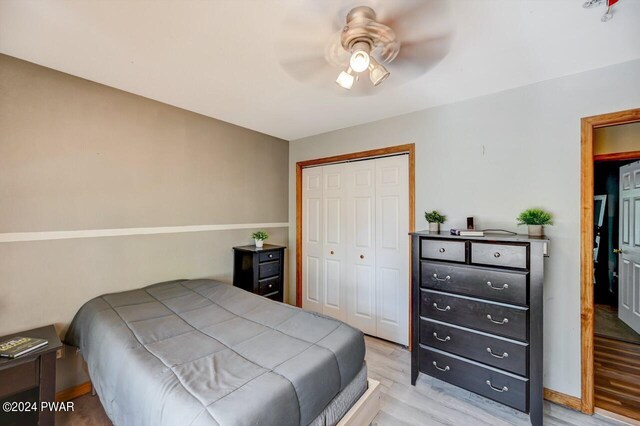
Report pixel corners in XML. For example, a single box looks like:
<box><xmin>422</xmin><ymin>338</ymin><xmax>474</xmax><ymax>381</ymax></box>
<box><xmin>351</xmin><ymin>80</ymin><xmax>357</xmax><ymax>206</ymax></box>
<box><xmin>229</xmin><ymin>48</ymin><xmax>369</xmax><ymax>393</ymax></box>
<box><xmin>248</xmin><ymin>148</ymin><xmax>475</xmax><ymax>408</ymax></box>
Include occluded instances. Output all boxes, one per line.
<box><xmin>375</xmin><ymin>155</ymin><xmax>409</xmax><ymax>345</ymax></box>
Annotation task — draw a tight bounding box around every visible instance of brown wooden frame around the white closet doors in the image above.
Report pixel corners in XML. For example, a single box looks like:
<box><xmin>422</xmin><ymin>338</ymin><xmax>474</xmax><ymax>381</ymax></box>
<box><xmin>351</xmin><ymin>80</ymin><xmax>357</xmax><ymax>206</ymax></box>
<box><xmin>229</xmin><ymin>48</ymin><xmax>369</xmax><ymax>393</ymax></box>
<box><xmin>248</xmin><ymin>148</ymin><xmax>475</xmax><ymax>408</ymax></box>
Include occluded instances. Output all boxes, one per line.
<box><xmin>296</xmin><ymin>144</ymin><xmax>415</xmax><ymax>350</ymax></box>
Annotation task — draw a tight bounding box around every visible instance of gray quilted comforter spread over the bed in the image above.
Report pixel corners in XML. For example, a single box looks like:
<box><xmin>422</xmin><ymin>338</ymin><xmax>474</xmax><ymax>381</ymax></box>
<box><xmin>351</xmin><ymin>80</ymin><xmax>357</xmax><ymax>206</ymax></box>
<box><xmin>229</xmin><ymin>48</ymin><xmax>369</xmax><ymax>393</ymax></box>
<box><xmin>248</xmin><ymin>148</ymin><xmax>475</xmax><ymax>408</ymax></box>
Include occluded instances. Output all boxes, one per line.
<box><xmin>66</xmin><ymin>280</ymin><xmax>365</xmax><ymax>425</ymax></box>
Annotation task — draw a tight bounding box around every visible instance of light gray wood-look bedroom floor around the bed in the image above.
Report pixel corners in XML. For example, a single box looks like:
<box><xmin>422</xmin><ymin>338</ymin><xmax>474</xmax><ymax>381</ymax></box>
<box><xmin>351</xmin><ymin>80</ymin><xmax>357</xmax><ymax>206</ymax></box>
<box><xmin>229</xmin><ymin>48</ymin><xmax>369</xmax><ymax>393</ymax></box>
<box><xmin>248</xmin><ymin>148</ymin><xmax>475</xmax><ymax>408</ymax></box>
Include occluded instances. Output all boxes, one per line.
<box><xmin>56</xmin><ymin>337</ymin><xmax>622</xmax><ymax>426</ymax></box>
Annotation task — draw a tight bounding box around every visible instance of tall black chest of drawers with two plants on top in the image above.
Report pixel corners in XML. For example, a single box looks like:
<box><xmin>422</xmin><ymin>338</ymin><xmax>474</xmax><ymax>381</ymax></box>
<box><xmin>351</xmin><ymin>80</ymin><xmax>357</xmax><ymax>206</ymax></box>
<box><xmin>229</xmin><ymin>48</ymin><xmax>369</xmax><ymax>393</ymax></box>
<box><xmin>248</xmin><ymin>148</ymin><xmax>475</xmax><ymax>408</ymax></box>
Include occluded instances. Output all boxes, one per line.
<box><xmin>411</xmin><ymin>232</ymin><xmax>549</xmax><ymax>425</ymax></box>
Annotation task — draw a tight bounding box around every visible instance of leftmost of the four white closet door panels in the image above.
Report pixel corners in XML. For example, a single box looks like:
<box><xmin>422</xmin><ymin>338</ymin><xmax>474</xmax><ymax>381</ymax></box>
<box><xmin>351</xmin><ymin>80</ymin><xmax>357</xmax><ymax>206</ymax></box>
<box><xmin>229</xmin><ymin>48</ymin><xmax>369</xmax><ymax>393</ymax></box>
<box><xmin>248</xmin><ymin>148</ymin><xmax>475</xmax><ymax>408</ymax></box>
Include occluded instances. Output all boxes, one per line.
<box><xmin>302</xmin><ymin>167</ymin><xmax>324</xmax><ymax>313</ymax></box>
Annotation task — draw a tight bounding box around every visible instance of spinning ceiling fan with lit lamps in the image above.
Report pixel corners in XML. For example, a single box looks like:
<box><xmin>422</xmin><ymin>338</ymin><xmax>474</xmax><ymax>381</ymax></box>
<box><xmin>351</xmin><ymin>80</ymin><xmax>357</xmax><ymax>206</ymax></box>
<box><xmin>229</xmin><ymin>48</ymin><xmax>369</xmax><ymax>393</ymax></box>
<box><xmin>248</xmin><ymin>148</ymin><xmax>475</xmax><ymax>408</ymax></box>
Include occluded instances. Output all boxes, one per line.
<box><xmin>275</xmin><ymin>0</ymin><xmax>453</xmax><ymax>96</ymax></box>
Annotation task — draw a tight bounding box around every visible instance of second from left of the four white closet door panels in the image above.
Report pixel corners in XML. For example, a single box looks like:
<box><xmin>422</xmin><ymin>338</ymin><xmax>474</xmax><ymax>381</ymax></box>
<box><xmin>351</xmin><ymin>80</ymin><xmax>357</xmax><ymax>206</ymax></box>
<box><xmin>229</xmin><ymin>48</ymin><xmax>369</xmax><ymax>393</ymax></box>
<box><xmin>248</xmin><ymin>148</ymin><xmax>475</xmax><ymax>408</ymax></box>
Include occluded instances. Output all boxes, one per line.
<box><xmin>322</xmin><ymin>164</ymin><xmax>347</xmax><ymax>321</ymax></box>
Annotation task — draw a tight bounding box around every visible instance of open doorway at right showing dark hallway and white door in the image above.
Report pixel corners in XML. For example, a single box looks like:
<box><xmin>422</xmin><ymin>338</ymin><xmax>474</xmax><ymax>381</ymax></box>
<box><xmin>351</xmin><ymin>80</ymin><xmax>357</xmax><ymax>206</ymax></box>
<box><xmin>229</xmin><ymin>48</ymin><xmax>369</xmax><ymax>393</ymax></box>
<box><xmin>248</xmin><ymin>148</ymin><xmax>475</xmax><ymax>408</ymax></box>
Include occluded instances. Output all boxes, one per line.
<box><xmin>593</xmin><ymin>152</ymin><xmax>640</xmax><ymax>420</ymax></box>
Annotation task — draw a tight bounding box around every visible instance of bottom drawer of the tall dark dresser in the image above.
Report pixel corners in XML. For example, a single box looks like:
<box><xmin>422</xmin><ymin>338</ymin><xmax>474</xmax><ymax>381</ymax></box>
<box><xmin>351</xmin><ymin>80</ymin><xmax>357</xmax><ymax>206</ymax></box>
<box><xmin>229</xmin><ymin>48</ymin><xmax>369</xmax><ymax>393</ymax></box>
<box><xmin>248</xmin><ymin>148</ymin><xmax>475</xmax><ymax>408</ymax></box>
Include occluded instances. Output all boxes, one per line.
<box><xmin>419</xmin><ymin>347</ymin><xmax>529</xmax><ymax>412</ymax></box>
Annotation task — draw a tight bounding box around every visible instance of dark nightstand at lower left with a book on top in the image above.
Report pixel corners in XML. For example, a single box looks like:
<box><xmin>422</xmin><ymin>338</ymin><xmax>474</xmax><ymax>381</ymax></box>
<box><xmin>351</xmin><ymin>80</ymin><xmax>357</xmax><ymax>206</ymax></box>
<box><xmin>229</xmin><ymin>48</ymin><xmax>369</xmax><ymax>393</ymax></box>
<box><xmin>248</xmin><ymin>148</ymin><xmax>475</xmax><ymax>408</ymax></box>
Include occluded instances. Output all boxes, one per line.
<box><xmin>0</xmin><ymin>325</ymin><xmax>62</xmax><ymax>425</ymax></box>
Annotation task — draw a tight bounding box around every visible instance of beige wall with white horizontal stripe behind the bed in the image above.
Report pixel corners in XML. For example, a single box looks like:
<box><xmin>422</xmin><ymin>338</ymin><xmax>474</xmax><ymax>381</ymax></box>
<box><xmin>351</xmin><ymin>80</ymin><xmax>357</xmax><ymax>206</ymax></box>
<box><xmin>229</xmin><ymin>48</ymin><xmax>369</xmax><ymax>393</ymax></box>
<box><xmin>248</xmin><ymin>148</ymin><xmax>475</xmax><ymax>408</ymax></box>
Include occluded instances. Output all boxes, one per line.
<box><xmin>0</xmin><ymin>55</ymin><xmax>288</xmax><ymax>389</ymax></box>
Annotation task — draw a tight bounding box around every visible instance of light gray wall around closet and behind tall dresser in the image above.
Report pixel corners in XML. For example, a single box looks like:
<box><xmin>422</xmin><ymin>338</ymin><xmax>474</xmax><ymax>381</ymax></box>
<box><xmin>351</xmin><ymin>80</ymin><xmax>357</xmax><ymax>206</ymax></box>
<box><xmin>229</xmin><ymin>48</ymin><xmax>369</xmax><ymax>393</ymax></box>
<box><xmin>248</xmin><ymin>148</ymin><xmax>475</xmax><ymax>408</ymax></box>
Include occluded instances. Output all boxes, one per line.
<box><xmin>289</xmin><ymin>61</ymin><xmax>640</xmax><ymax>396</ymax></box>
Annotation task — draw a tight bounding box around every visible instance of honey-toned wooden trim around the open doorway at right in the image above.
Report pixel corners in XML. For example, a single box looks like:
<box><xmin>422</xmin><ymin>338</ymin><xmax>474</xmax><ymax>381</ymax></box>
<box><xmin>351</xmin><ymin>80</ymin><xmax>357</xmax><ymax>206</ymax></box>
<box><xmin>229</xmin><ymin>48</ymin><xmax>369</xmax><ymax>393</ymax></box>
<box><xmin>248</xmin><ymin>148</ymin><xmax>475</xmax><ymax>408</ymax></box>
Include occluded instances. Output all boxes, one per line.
<box><xmin>580</xmin><ymin>108</ymin><xmax>640</xmax><ymax>414</ymax></box>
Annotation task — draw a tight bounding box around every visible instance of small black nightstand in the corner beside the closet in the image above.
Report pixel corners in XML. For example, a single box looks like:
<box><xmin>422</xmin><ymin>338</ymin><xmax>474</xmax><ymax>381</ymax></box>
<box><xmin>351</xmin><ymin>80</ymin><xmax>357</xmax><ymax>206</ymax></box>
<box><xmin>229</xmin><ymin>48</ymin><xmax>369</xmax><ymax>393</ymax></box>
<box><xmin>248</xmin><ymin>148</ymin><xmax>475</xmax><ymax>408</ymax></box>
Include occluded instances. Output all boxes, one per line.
<box><xmin>233</xmin><ymin>244</ymin><xmax>286</xmax><ymax>302</ymax></box>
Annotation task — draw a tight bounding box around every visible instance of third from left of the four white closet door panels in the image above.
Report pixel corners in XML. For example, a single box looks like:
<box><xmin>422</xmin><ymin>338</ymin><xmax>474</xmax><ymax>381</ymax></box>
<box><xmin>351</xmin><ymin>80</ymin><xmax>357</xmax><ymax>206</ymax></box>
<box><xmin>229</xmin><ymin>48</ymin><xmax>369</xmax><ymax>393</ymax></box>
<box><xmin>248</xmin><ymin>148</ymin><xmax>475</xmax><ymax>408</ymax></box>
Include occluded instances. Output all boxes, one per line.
<box><xmin>345</xmin><ymin>160</ymin><xmax>377</xmax><ymax>336</ymax></box>
